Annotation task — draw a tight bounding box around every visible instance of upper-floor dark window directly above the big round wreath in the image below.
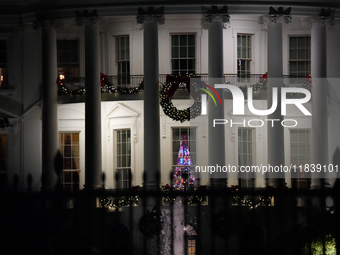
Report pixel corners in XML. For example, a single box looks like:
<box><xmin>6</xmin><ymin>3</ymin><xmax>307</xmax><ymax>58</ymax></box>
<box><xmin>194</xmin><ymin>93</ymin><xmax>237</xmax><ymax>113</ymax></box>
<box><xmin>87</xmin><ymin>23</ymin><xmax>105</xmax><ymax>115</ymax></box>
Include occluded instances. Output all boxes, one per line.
<box><xmin>171</xmin><ymin>34</ymin><xmax>196</xmax><ymax>75</ymax></box>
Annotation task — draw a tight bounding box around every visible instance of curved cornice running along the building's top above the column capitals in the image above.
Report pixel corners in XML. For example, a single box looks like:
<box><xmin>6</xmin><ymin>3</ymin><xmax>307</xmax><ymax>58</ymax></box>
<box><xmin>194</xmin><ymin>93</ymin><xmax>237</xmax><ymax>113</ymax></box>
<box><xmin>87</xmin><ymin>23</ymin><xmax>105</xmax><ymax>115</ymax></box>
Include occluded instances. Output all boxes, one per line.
<box><xmin>0</xmin><ymin>0</ymin><xmax>340</xmax><ymax>31</ymax></box>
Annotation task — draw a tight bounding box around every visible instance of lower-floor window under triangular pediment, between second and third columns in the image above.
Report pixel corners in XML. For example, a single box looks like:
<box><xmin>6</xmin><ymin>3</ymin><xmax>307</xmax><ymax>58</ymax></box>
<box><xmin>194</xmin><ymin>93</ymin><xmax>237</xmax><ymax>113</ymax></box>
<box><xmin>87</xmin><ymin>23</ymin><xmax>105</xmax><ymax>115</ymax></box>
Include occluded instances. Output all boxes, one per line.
<box><xmin>116</xmin><ymin>129</ymin><xmax>131</xmax><ymax>189</ymax></box>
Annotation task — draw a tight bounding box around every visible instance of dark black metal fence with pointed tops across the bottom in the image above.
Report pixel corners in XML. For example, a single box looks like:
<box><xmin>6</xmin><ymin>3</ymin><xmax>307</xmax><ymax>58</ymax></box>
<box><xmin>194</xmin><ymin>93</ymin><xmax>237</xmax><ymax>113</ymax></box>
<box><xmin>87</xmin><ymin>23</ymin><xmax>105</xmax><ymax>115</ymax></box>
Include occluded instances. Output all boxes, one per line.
<box><xmin>0</xmin><ymin>182</ymin><xmax>340</xmax><ymax>255</ymax></box>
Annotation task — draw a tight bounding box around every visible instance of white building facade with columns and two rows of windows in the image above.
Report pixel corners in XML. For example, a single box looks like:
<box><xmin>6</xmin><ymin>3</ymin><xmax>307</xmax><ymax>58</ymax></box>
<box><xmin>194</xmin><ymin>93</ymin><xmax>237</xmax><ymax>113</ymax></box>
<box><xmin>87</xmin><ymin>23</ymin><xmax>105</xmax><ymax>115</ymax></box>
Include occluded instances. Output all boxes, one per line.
<box><xmin>0</xmin><ymin>1</ymin><xmax>340</xmax><ymax>190</ymax></box>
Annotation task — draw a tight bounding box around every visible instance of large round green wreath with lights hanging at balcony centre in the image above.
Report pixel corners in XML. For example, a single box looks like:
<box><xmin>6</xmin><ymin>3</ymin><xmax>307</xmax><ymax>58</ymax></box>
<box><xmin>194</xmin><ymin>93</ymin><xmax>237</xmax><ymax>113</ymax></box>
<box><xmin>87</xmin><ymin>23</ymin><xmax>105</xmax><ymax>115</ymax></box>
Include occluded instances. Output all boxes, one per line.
<box><xmin>160</xmin><ymin>84</ymin><xmax>201</xmax><ymax>122</ymax></box>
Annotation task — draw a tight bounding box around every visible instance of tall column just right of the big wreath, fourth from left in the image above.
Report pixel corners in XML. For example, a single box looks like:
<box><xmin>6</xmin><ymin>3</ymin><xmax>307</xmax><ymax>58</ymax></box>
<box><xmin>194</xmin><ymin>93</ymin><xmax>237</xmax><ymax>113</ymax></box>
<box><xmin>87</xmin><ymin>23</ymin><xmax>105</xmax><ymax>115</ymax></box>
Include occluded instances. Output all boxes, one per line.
<box><xmin>207</xmin><ymin>15</ymin><xmax>224</xmax><ymax>186</ymax></box>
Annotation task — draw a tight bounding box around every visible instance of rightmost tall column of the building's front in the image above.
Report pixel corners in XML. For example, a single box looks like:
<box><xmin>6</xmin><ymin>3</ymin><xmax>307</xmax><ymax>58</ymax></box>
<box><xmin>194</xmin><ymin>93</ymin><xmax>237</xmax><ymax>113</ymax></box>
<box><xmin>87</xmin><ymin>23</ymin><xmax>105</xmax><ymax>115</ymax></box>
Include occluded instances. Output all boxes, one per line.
<box><xmin>311</xmin><ymin>22</ymin><xmax>329</xmax><ymax>188</ymax></box>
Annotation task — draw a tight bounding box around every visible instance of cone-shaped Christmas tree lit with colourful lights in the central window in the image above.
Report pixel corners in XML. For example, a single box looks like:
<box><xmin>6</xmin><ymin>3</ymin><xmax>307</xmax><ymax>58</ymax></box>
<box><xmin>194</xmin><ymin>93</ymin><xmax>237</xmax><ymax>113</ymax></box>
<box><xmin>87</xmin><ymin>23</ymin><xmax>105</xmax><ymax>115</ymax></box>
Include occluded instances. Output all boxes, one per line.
<box><xmin>173</xmin><ymin>135</ymin><xmax>197</xmax><ymax>191</ymax></box>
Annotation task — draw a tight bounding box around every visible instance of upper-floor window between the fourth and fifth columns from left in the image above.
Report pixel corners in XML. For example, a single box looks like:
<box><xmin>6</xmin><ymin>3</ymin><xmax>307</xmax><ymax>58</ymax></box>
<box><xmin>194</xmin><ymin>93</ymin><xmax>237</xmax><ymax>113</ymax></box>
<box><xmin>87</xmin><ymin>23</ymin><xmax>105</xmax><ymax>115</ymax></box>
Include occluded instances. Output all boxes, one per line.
<box><xmin>237</xmin><ymin>34</ymin><xmax>252</xmax><ymax>77</ymax></box>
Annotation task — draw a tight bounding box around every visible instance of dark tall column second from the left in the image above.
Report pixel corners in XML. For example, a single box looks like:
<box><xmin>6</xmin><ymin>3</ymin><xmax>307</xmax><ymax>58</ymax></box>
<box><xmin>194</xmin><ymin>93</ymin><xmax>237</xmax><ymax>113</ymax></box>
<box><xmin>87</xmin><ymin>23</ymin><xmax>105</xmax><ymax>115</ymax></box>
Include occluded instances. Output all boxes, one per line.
<box><xmin>85</xmin><ymin>21</ymin><xmax>102</xmax><ymax>189</ymax></box>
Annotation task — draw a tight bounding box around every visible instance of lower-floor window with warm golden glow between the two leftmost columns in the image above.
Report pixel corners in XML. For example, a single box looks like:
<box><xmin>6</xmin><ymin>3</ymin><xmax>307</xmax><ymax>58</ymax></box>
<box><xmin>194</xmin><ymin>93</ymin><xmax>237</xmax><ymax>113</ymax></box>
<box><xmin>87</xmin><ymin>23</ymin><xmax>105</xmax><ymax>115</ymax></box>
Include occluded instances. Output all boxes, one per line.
<box><xmin>59</xmin><ymin>132</ymin><xmax>80</xmax><ymax>191</ymax></box>
